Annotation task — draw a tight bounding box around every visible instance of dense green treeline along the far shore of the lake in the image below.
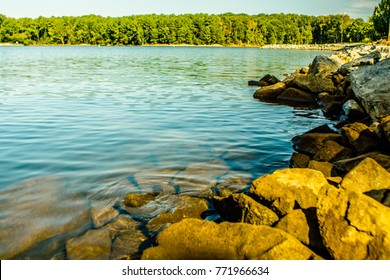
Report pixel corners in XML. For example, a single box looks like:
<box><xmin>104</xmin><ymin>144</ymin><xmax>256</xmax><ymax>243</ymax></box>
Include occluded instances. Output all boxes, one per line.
<box><xmin>0</xmin><ymin>13</ymin><xmax>379</xmax><ymax>46</ymax></box>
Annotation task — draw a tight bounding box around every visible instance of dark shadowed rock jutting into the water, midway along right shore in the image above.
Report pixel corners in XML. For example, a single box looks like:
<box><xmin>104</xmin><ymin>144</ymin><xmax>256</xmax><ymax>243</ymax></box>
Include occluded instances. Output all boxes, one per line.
<box><xmin>291</xmin><ymin>132</ymin><xmax>342</xmax><ymax>156</ymax></box>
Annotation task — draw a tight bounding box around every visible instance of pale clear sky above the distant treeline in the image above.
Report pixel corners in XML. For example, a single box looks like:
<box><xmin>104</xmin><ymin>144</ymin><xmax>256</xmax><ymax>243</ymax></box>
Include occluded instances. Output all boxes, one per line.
<box><xmin>0</xmin><ymin>0</ymin><xmax>380</xmax><ymax>20</ymax></box>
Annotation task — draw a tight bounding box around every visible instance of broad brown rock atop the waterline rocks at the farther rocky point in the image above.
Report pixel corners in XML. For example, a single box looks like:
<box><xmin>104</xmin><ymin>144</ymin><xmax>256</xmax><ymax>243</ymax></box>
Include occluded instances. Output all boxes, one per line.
<box><xmin>290</xmin><ymin>74</ymin><xmax>336</xmax><ymax>93</ymax></box>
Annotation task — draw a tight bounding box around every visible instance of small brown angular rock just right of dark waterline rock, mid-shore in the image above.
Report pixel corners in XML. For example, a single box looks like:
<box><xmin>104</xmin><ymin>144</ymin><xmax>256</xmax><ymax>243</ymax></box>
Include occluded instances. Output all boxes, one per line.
<box><xmin>313</xmin><ymin>140</ymin><xmax>353</xmax><ymax>163</ymax></box>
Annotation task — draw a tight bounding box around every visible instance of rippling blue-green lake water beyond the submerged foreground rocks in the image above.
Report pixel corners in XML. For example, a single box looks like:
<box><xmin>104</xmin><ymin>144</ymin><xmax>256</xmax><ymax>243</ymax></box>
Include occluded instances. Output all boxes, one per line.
<box><xmin>0</xmin><ymin>47</ymin><xmax>328</xmax><ymax>258</ymax></box>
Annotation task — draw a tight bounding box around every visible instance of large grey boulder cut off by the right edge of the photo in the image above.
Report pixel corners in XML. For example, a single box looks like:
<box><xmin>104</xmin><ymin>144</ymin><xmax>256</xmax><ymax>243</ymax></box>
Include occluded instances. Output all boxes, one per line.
<box><xmin>349</xmin><ymin>59</ymin><xmax>390</xmax><ymax>120</ymax></box>
